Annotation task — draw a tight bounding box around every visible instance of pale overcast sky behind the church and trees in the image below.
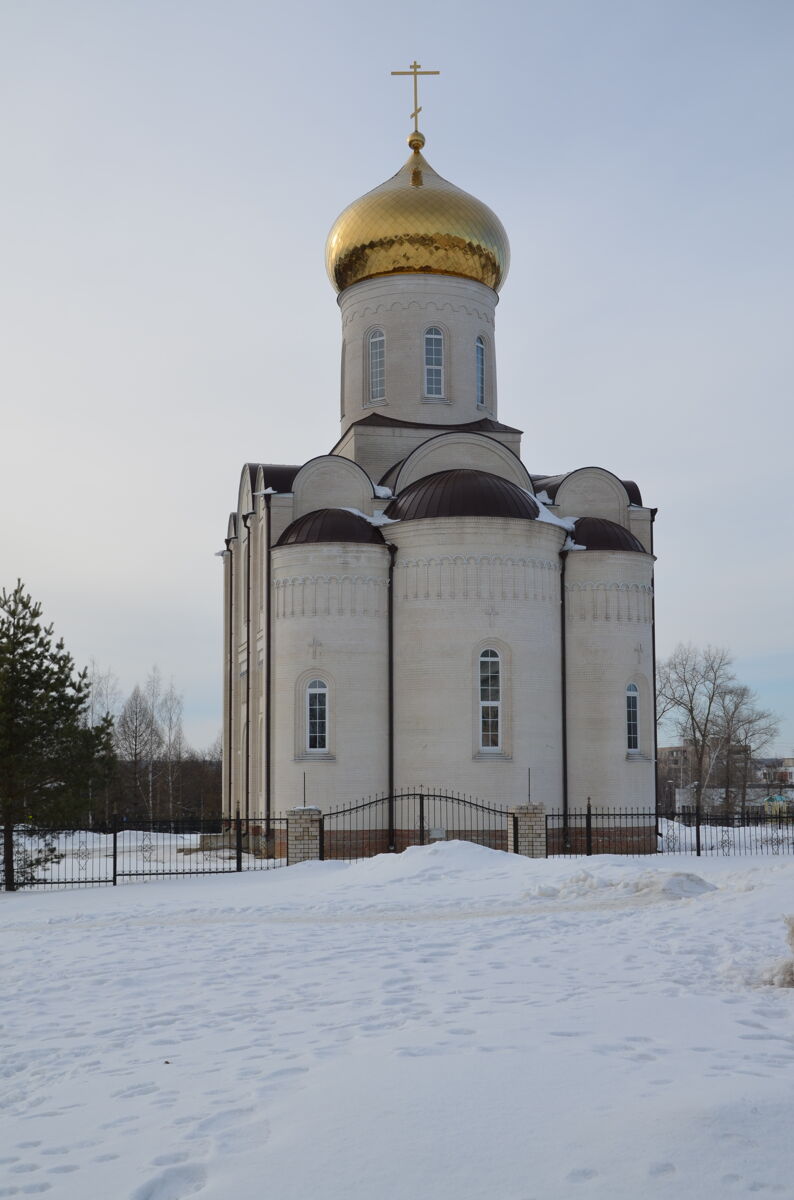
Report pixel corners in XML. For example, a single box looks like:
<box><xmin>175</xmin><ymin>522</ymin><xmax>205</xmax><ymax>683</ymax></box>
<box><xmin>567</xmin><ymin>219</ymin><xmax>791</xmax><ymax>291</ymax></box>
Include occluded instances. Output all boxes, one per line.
<box><xmin>0</xmin><ymin>0</ymin><xmax>794</xmax><ymax>754</ymax></box>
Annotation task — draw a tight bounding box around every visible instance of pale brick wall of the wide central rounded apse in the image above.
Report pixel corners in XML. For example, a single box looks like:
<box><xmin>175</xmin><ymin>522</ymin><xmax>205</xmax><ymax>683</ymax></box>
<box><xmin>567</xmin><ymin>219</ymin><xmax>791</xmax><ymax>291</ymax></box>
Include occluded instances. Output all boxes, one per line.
<box><xmin>389</xmin><ymin>517</ymin><xmax>565</xmax><ymax>805</ymax></box>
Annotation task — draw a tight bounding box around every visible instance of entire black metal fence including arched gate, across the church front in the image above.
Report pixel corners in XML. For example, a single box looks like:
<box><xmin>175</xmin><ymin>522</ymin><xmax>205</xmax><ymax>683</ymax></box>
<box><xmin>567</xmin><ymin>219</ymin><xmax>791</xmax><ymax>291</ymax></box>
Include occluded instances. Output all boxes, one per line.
<box><xmin>6</xmin><ymin>788</ymin><xmax>794</xmax><ymax>888</ymax></box>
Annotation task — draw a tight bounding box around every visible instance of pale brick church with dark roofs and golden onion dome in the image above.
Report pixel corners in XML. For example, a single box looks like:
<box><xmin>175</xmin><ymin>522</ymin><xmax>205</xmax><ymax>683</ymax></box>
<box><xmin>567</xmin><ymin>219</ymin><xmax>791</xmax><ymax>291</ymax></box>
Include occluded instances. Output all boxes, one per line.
<box><xmin>223</xmin><ymin>76</ymin><xmax>656</xmax><ymax>820</ymax></box>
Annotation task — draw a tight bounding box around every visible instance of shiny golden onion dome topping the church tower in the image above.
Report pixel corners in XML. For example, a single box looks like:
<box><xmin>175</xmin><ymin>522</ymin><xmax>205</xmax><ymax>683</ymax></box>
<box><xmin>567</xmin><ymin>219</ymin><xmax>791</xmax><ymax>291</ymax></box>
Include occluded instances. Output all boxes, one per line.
<box><xmin>325</xmin><ymin>132</ymin><xmax>510</xmax><ymax>292</ymax></box>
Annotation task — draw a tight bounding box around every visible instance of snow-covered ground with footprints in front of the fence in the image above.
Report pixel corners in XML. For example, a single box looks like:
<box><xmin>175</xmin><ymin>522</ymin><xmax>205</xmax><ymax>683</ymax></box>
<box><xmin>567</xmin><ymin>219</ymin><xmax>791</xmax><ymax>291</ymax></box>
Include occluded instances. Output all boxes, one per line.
<box><xmin>0</xmin><ymin>842</ymin><xmax>794</xmax><ymax>1200</ymax></box>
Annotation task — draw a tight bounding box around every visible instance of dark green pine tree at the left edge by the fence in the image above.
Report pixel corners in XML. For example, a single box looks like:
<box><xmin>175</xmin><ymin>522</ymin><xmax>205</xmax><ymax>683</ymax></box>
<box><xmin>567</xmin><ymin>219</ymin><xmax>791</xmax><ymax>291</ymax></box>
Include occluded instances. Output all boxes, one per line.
<box><xmin>0</xmin><ymin>581</ymin><xmax>113</xmax><ymax>890</ymax></box>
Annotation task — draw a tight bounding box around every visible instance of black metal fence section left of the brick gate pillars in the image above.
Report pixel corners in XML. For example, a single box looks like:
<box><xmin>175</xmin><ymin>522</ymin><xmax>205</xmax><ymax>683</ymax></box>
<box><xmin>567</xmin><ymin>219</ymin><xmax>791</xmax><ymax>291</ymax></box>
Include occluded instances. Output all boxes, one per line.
<box><xmin>0</xmin><ymin>817</ymin><xmax>287</xmax><ymax>889</ymax></box>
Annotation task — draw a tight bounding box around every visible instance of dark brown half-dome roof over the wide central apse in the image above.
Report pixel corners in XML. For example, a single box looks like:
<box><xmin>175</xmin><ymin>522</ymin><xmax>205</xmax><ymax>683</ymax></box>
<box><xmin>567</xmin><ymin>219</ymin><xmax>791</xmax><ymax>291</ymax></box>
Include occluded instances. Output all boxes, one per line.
<box><xmin>385</xmin><ymin>469</ymin><xmax>540</xmax><ymax>521</ymax></box>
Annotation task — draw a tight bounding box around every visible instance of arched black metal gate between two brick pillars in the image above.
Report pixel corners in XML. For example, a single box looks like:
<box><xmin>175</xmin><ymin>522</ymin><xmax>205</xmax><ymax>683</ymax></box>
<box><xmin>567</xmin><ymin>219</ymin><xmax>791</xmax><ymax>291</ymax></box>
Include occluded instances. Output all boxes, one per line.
<box><xmin>320</xmin><ymin>788</ymin><xmax>510</xmax><ymax>860</ymax></box>
